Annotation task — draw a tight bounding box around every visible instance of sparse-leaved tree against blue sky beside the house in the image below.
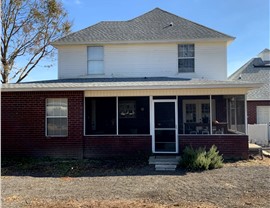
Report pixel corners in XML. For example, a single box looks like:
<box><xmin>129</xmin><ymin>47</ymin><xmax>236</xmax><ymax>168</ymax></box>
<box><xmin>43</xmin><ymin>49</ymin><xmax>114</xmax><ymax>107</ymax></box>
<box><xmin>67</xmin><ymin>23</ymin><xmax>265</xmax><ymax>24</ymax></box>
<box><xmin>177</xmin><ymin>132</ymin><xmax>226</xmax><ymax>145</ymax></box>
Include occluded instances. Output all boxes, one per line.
<box><xmin>1</xmin><ymin>0</ymin><xmax>71</xmax><ymax>83</ymax></box>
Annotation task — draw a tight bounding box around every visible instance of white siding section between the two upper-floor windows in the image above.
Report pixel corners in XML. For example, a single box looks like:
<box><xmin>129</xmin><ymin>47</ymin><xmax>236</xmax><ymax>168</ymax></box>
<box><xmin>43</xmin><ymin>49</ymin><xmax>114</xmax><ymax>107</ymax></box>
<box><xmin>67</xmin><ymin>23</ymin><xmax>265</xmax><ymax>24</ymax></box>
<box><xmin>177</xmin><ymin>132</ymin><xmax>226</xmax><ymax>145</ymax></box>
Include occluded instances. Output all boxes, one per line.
<box><xmin>105</xmin><ymin>44</ymin><xmax>177</xmax><ymax>77</ymax></box>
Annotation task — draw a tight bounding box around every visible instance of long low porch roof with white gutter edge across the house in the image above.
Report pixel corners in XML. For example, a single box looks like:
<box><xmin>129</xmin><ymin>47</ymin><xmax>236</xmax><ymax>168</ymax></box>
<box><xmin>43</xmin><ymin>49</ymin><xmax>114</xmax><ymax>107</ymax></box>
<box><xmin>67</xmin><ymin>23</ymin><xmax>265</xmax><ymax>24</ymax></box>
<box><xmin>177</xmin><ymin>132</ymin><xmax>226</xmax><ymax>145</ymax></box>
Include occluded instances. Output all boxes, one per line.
<box><xmin>2</xmin><ymin>77</ymin><xmax>260</xmax><ymax>91</ymax></box>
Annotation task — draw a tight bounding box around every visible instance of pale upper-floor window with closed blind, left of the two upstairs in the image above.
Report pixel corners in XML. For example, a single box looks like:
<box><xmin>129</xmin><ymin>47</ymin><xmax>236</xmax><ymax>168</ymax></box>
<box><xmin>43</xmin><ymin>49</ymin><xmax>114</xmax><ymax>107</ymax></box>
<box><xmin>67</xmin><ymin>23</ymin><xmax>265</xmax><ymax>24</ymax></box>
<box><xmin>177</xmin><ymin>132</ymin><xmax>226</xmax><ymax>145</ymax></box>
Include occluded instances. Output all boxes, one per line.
<box><xmin>87</xmin><ymin>46</ymin><xmax>104</xmax><ymax>74</ymax></box>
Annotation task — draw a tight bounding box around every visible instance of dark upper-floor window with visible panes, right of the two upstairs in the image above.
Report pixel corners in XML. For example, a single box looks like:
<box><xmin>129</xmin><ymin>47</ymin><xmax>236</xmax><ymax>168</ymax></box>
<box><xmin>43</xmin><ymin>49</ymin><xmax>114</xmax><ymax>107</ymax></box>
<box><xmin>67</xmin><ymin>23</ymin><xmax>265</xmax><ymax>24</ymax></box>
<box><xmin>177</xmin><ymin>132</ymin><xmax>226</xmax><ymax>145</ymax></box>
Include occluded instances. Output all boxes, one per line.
<box><xmin>178</xmin><ymin>44</ymin><xmax>195</xmax><ymax>73</ymax></box>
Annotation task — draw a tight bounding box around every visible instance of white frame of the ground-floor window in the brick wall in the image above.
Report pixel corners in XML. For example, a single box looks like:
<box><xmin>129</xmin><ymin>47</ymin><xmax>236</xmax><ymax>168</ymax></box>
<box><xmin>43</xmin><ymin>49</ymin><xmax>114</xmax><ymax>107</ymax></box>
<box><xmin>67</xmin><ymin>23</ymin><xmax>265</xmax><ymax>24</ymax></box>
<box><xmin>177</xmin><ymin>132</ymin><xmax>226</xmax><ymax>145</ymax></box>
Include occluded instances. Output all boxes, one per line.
<box><xmin>45</xmin><ymin>98</ymin><xmax>68</xmax><ymax>137</ymax></box>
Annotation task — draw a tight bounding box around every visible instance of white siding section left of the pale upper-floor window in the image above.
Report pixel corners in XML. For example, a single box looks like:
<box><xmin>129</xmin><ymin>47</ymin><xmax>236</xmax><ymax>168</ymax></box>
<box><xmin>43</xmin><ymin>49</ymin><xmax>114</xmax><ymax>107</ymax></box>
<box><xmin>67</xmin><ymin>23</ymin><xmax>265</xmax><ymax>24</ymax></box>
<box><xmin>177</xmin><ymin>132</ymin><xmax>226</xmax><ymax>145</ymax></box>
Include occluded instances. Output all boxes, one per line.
<box><xmin>58</xmin><ymin>46</ymin><xmax>87</xmax><ymax>79</ymax></box>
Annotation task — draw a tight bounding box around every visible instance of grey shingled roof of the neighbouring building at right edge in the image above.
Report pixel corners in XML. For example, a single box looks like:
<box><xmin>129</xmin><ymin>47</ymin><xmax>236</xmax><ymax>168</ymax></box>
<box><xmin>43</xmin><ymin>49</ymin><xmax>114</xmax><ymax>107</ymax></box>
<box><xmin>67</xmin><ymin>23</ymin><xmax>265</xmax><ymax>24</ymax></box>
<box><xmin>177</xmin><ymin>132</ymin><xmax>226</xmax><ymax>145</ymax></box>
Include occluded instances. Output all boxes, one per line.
<box><xmin>229</xmin><ymin>49</ymin><xmax>270</xmax><ymax>100</ymax></box>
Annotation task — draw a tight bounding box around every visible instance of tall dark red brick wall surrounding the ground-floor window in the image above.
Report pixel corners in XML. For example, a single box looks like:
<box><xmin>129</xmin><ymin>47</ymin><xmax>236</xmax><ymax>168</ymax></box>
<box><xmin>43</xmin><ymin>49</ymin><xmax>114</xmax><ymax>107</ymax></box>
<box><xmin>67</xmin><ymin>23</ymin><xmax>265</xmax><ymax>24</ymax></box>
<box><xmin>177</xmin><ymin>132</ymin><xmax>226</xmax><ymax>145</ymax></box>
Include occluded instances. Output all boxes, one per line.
<box><xmin>1</xmin><ymin>91</ymin><xmax>83</xmax><ymax>158</ymax></box>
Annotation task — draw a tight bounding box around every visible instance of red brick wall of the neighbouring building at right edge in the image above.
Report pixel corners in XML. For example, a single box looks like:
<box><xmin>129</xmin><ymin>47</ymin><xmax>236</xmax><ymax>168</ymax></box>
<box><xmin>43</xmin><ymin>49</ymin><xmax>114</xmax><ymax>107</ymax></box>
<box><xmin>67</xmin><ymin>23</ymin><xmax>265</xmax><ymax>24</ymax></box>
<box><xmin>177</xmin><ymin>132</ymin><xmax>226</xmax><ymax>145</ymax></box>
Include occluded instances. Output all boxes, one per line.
<box><xmin>247</xmin><ymin>101</ymin><xmax>270</xmax><ymax>124</ymax></box>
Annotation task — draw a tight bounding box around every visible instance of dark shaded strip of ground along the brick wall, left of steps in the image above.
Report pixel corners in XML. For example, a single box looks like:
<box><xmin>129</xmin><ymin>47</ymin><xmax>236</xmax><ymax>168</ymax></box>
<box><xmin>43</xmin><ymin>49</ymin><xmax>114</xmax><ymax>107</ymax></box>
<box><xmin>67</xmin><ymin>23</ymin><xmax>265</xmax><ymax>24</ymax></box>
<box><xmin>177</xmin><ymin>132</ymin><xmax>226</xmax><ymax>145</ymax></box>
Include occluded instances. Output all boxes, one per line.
<box><xmin>1</xmin><ymin>157</ymin><xmax>148</xmax><ymax>177</ymax></box>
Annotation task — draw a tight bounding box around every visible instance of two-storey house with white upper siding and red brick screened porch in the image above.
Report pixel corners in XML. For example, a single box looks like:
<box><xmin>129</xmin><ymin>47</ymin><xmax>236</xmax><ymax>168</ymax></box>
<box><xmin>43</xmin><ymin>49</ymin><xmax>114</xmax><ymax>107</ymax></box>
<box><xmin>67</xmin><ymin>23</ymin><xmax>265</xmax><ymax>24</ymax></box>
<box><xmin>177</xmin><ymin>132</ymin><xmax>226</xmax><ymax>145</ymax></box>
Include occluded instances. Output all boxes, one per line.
<box><xmin>2</xmin><ymin>8</ymin><xmax>258</xmax><ymax>158</ymax></box>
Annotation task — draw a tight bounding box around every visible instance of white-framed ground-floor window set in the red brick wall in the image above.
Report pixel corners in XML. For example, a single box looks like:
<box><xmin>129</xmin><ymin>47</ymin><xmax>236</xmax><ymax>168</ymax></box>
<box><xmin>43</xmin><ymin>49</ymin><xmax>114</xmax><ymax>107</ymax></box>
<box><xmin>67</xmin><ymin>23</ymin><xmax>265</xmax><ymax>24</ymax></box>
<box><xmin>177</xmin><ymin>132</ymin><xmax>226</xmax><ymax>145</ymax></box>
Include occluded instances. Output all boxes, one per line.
<box><xmin>46</xmin><ymin>98</ymin><xmax>68</xmax><ymax>136</ymax></box>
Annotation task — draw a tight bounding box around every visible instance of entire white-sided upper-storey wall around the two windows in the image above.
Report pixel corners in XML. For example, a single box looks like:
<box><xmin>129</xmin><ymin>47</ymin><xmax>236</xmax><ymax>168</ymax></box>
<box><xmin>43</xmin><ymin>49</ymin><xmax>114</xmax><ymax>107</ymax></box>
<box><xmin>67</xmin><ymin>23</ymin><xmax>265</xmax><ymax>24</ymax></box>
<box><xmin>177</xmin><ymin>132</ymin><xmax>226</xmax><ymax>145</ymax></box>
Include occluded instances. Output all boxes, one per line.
<box><xmin>58</xmin><ymin>42</ymin><xmax>227</xmax><ymax>80</ymax></box>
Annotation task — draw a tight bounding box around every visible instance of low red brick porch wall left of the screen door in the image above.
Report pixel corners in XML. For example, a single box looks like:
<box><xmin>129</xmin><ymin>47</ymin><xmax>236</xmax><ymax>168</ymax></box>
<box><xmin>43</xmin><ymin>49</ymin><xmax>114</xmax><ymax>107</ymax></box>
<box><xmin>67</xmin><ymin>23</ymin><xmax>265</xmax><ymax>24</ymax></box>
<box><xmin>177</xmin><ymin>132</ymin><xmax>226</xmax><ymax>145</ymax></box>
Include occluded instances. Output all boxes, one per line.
<box><xmin>84</xmin><ymin>136</ymin><xmax>152</xmax><ymax>158</ymax></box>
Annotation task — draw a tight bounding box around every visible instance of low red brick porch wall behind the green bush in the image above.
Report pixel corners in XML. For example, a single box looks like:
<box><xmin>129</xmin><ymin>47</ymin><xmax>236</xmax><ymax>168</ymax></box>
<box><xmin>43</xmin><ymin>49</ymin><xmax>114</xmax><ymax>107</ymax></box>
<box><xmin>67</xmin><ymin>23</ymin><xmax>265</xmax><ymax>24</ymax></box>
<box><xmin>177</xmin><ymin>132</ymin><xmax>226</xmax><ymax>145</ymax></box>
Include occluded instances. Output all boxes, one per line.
<box><xmin>179</xmin><ymin>135</ymin><xmax>248</xmax><ymax>159</ymax></box>
